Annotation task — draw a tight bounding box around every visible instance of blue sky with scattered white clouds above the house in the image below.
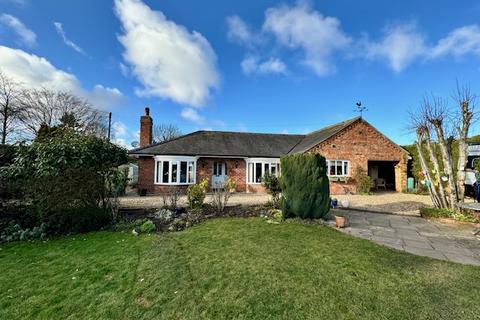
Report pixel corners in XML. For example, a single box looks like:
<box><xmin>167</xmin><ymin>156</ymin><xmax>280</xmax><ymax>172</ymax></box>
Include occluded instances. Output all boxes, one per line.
<box><xmin>0</xmin><ymin>0</ymin><xmax>480</xmax><ymax>145</ymax></box>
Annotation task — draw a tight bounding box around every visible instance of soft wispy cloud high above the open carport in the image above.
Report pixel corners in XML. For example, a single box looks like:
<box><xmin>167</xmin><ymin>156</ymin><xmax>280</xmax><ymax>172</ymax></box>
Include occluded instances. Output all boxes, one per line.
<box><xmin>361</xmin><ymin>22</ymin><xmax>428</xmax><ymax>73</ymax></box>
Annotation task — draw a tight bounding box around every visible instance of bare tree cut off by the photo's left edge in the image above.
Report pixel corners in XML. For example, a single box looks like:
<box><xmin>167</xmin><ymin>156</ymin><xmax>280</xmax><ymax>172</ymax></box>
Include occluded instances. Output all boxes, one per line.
<box><xmin>0</xmin><ymin>71</ymin><xmax>22</xmax><ymax>144</ymax></box>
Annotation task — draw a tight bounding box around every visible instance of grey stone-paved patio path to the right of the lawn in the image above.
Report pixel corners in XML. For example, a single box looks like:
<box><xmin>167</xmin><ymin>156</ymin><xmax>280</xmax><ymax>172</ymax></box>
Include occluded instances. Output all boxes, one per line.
<box><xmin>332</xmin><ymin>210</ymin><xmax>480</xmax><ymax>266</ymax></box>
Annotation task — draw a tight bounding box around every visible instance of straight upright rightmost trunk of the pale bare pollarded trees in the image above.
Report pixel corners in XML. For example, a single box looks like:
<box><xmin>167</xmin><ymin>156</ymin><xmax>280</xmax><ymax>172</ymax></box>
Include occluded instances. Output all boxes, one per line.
<box><xmin>454</xmin><ymin>83</ymin><xmax>475</xmax><ymax>201</ymax></box>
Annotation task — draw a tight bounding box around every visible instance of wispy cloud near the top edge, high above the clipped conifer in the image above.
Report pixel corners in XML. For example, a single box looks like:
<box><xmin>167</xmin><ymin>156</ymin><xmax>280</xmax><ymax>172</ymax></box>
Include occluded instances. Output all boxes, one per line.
<box><xmin>263</xmin><ymin>2</ymin><xmax>351</xmax><ymax>76</ymax></box>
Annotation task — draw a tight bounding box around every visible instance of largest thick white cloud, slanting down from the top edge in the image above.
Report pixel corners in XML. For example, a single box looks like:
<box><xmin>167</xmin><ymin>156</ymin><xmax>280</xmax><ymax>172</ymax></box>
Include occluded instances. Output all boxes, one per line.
<box><xmin>115</xmin><ymin>0</ymin><xmax>219</xmax><ymax>107</ymax></box>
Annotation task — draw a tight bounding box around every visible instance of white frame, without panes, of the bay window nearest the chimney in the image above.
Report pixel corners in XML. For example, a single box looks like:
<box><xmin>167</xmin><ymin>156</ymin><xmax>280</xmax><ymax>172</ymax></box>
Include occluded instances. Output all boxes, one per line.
<box><xmin>153</xmin><ymin>156</ymin><xmax>198</xmax><ymax>186</ymax></box>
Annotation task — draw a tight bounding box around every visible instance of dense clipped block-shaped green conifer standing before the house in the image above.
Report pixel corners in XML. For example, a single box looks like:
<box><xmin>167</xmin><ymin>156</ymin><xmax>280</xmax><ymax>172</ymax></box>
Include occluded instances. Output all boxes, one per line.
<box><xmin>281</xmin><ymin>154</ymin><xmax>330</xmax><ymax>219</ymax></box>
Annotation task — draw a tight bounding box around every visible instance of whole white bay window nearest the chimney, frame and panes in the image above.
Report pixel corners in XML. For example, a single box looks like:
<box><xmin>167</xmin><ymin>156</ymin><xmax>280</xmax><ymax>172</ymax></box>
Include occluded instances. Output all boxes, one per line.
<box><xmin>154</xmin><ymin>156</ymin><xmax>197</xmax><ymax>185</ymax></box>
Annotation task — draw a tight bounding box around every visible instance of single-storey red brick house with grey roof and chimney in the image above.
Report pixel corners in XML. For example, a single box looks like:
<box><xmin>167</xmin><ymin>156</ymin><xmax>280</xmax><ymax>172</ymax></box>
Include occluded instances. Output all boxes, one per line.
<box><xmin>130</xmin><ymin>108</ymin><xmax>408</xmax><ymax>194</ymax></box>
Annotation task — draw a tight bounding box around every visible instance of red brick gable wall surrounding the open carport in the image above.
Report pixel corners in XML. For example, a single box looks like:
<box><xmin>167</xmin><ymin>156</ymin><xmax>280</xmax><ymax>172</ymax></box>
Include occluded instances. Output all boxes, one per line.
<box><xmin>309</xmin><ymin>121</ymin><xmax>407</xmax><ymax>194</ymax></box>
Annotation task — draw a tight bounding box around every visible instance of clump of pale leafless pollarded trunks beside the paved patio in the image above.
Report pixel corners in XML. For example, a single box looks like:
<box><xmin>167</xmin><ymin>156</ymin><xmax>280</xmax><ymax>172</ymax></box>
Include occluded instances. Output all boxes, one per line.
<box><xmin>410</xmin><ymin>85</ymin><xmax>475</xmax><ymax>210</ymax></box>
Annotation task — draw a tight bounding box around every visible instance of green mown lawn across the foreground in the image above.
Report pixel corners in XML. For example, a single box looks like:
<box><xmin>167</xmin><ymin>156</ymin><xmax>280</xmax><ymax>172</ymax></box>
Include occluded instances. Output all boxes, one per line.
<box><xmin>0</xmin><ymin>218</ymin><xmax>480</xmax><ymax>319</ymax></box>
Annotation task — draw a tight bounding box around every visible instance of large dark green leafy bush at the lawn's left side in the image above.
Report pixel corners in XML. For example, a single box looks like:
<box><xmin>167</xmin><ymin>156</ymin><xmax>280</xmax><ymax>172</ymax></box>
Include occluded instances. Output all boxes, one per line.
<box><xmin>0</xmin><ymin>129</ymin><xmax>128</xmax><ymax>234</ymax></box>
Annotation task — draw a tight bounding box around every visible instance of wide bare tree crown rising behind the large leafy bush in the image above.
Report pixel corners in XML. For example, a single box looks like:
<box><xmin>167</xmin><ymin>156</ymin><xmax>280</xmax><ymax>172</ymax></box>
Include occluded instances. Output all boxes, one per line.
<box><xmin>20</xmin><ymin>88</ymin><xmax>107</xmax><ymax>137</ymax></box>
